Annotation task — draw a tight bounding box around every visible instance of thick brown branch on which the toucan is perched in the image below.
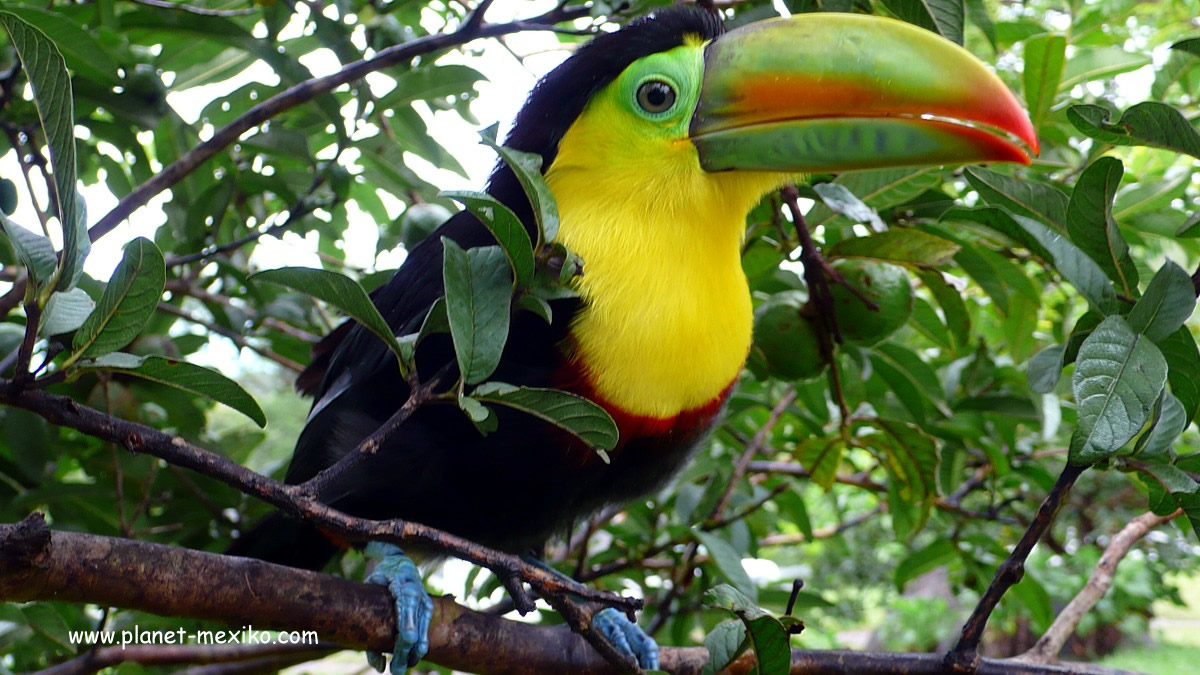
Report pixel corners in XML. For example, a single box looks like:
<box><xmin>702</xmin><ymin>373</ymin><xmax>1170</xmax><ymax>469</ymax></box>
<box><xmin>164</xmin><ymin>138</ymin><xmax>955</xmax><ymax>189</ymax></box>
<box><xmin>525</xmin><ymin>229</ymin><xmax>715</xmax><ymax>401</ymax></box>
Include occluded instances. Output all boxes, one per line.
<box><xmin>0</xmin><ymin>515</ymin><xmax>1120</xmax><ymax>675</ymax></box>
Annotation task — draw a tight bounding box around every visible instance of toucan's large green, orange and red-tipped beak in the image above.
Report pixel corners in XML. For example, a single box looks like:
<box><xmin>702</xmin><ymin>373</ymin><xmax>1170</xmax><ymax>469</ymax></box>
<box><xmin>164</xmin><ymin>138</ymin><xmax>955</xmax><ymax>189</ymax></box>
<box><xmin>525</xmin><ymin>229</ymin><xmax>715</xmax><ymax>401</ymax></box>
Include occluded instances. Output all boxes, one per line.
<box><xmin>690</xmin><ymin>14</ymin><xmax>1038</xmax><ymax>173</ymax></box>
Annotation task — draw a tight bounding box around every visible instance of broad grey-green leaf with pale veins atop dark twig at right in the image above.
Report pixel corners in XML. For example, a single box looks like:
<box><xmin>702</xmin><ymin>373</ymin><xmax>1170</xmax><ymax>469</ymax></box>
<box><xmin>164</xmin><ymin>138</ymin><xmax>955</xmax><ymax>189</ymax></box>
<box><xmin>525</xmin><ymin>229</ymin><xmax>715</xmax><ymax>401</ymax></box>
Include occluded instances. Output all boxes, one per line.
<box><xmin>1070</xmin><ymin>316</ymin><xmax>1166</xmax><ymax>465</ymax></box>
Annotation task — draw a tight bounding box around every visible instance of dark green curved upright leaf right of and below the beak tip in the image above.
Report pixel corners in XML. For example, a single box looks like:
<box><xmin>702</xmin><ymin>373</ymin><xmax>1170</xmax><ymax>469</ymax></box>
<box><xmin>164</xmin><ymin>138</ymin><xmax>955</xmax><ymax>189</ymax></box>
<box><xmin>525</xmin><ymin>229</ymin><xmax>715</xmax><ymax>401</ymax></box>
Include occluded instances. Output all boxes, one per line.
<box><xmin>1067</xmin><ymin>157</ymin><xmax>1138</xmax><ymax>298</ymax></box>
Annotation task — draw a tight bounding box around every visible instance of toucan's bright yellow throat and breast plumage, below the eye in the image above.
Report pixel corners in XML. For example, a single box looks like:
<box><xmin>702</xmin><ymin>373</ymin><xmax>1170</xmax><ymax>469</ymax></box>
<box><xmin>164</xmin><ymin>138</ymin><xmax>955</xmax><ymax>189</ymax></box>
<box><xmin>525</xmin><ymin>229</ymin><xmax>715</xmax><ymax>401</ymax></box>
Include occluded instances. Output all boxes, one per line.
<box><xmin>546</xmin><ymin>51</ymin><xmax>785</xmax><ymax>418</ymax></box>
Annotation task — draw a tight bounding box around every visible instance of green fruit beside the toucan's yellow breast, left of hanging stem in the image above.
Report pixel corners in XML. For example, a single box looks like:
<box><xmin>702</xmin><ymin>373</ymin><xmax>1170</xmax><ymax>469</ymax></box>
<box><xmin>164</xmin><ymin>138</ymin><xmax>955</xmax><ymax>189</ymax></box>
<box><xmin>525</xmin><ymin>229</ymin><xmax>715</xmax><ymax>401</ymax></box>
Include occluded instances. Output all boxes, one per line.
<box><xmin>752</xmin><ymin>295</ymin><xmax>827</xmax><ymax>380</ymax></box>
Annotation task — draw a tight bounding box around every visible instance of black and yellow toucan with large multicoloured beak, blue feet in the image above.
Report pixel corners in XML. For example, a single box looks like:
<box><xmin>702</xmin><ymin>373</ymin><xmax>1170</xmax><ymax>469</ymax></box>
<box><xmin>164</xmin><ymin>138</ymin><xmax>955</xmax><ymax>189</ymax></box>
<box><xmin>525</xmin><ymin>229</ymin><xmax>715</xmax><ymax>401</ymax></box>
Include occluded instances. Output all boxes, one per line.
<box><xmin>230</xmin><ymin>5</ymin><xmax>1037</xmax><ymax>673</ymax></box>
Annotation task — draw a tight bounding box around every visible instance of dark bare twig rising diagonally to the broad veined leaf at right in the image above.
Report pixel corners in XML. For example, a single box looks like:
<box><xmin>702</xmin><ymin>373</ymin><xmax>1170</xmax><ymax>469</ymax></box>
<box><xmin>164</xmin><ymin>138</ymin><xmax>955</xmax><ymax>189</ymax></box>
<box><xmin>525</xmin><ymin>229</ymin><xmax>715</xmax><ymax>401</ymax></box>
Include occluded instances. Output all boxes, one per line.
<box><xmin>946</xmin><ymin>462</ymin><xmax>1087</xmax><ymax>673</ymax></box>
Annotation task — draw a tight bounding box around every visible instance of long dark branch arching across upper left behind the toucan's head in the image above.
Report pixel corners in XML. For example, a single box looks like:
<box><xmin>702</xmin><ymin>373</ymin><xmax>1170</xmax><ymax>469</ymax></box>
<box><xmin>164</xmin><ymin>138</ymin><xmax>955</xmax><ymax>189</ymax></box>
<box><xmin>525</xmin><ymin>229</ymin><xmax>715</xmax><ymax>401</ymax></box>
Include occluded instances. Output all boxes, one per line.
<box><xmin>88</xmin><ymin>5</ymin><xmax>589</xmax><ymax>241</ymax></box>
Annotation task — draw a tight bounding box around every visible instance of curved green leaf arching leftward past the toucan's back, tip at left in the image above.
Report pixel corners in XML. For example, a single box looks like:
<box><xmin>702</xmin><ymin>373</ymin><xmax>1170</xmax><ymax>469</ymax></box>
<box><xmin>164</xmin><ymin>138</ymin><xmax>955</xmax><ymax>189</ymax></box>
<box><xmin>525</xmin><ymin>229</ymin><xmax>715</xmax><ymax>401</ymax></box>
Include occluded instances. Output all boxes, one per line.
<box><xmin>250</xmin><ymin>267</ymin><xmax>408</xmax><ymax>377</ymax></box>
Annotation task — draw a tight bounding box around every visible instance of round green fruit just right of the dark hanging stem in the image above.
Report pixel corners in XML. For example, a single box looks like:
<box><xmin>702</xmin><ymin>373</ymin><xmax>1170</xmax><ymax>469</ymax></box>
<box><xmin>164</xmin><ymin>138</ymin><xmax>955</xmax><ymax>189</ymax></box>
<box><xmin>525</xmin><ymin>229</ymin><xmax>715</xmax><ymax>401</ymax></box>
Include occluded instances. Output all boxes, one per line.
<box><xmin>829</xmin><ymin>258</ymin><xmax>912</xmax><ymax>346</ymax></box>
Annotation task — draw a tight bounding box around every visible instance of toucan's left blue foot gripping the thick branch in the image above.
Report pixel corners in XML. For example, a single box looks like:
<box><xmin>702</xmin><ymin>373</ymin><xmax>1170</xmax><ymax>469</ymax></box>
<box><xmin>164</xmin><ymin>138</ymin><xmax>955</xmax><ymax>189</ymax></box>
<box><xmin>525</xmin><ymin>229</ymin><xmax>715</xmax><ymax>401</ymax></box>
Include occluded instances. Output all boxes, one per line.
<box><xmin>366</xmin><ymin>542</ymin><xmax>433</xmax><ymax>675</ymax></box>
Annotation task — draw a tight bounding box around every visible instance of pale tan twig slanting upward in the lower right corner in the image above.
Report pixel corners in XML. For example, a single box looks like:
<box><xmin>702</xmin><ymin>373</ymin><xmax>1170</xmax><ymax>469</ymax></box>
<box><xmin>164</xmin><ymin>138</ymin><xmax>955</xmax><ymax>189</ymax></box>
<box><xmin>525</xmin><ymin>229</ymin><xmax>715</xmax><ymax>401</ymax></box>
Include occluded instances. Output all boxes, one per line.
<box><xmin>1018</xmin><ymin>508</ymin><xmax>1183</xmax><ymax>663</ymax></box>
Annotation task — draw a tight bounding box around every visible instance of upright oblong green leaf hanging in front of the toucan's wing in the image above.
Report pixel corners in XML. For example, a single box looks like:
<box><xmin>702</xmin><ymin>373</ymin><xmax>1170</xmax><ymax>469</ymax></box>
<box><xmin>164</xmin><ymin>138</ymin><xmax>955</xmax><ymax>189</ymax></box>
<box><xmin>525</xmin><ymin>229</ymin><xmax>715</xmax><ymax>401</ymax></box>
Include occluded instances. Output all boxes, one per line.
<box><xmin>442</xmin><ymin>237</ymin><xmax>512</xmax><ymax>384</ymax></box>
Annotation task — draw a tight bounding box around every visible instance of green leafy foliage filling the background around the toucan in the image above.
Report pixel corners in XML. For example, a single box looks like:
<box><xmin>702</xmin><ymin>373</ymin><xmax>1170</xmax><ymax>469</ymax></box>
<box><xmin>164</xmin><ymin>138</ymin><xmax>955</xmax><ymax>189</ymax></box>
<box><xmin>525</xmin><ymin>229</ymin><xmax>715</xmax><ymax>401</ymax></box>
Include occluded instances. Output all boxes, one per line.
<box><xmin>0</xmin><ymin>0</ymin><xmax>1200</xmax><ymax>670</ymax></box>
